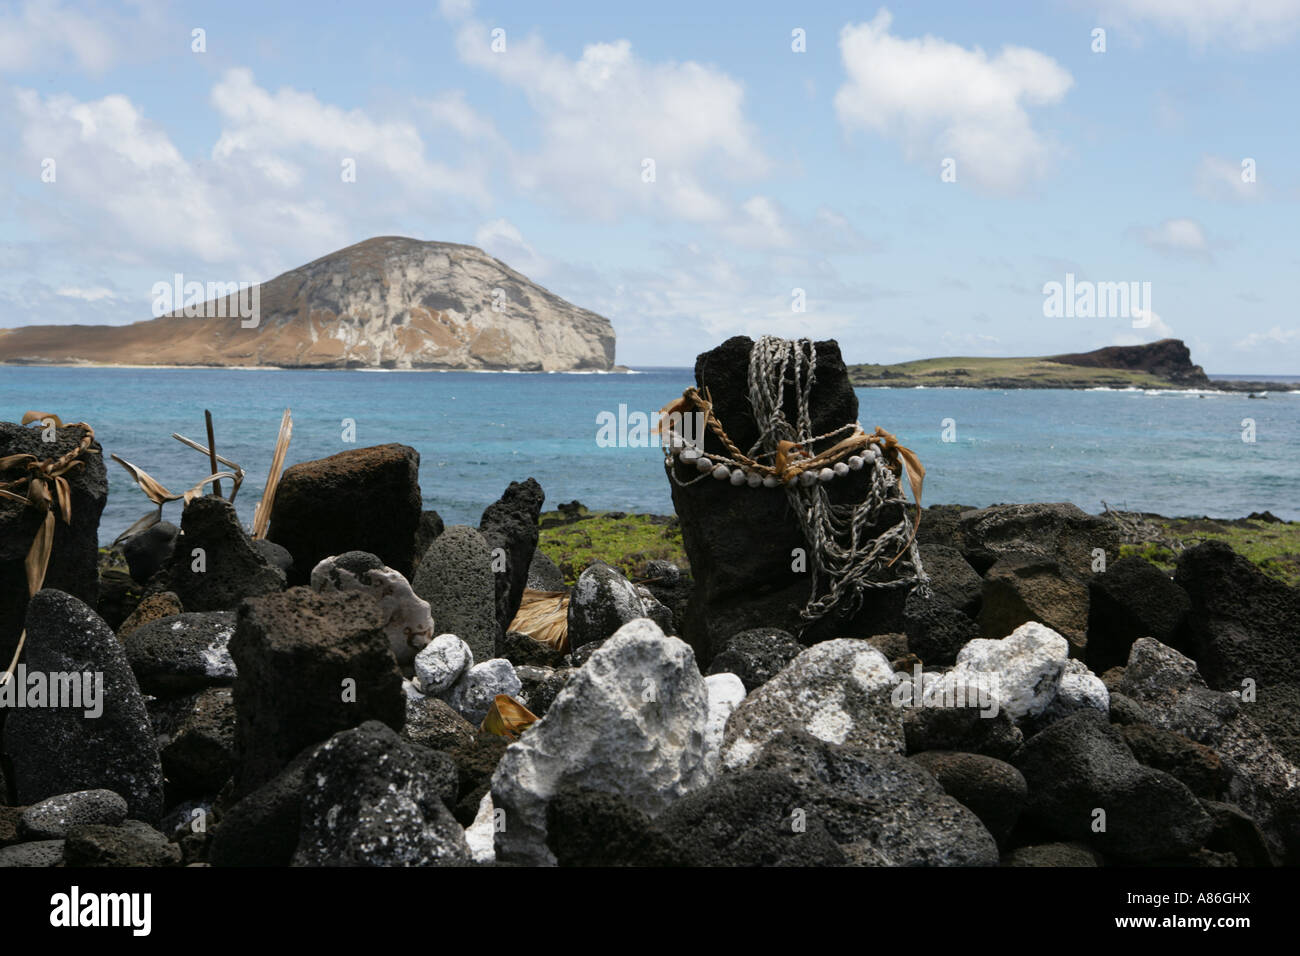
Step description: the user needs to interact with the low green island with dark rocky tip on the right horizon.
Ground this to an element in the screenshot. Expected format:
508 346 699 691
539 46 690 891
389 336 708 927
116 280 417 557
849 338 1295 392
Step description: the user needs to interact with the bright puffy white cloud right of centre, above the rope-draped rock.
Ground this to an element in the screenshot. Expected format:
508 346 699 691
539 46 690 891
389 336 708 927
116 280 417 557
835 8 1074 193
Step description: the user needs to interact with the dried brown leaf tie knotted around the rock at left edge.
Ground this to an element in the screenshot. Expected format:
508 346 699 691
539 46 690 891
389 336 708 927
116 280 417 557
0 411 99 685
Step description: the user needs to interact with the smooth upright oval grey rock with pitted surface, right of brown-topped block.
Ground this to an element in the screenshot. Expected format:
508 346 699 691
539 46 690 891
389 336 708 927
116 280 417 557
411 524 497 661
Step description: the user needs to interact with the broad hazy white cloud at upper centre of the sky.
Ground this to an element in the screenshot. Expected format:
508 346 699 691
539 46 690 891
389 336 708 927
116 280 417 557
456 12 768 224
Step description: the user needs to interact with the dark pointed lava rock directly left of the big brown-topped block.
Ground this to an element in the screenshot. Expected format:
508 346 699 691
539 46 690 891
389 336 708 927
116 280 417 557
160 496 285 611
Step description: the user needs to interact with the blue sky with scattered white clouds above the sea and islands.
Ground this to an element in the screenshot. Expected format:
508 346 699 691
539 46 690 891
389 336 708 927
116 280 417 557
0 0 1300 376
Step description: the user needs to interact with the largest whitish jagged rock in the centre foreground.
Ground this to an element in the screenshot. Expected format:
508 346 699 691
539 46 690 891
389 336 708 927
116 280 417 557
491 619 709 864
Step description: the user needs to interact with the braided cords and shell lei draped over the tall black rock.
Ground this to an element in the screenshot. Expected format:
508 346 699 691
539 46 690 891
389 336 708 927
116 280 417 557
659 336 930 623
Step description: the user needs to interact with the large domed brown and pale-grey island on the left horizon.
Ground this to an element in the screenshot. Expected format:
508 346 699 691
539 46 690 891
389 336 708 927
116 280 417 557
0 237 614 372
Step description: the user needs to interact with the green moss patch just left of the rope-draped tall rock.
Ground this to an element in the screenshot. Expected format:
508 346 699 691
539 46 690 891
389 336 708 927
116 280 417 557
538 506 688 585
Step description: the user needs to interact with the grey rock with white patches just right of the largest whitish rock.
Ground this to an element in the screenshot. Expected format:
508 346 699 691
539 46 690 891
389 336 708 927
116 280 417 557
723 639 905 770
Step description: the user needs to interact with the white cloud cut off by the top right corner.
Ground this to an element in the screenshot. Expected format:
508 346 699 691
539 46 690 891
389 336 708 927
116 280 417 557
1096 0 1300 49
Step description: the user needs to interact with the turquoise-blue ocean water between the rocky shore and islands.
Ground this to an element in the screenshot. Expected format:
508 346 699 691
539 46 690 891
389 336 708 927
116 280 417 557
0 367 1300 542
